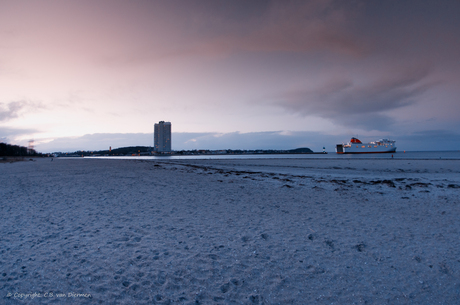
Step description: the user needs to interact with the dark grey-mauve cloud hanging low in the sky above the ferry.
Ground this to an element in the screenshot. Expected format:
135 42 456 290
273 67 435 130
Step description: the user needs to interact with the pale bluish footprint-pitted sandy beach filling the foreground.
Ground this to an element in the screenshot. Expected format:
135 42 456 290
0 158 460 304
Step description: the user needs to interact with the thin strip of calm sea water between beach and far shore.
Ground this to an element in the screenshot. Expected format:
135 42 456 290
85 150 460 160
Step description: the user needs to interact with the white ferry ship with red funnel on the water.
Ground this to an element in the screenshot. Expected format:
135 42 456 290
335 138 396 154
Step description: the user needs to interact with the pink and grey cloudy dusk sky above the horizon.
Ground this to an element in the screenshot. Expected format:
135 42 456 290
0 0 460 152
